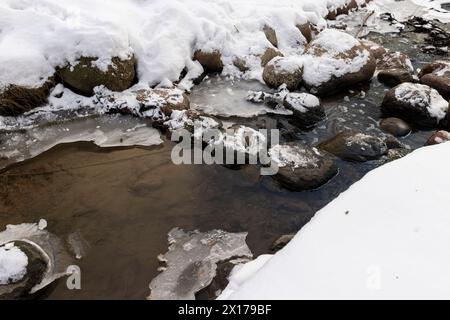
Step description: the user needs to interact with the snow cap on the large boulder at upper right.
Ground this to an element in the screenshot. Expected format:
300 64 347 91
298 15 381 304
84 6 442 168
302 29 370 86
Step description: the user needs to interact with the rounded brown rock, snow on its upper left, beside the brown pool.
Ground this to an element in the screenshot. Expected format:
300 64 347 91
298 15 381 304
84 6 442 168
269 142 338 191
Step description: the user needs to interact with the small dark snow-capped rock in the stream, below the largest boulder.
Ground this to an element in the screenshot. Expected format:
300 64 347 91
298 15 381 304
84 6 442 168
283 92 325 129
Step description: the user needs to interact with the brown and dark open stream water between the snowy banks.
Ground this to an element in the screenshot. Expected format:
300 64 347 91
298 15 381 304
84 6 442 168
0 28 442 299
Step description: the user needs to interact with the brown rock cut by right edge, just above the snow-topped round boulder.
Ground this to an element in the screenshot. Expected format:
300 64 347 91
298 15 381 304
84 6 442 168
419 60 450 99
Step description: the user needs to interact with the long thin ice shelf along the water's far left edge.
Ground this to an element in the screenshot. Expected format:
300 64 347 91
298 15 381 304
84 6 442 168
0 115 163 168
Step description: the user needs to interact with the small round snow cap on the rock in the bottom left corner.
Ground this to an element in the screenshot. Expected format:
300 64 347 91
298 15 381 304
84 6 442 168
0 243 28 285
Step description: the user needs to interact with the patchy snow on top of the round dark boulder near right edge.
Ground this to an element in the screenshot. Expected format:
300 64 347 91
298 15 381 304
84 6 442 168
395 82 448 120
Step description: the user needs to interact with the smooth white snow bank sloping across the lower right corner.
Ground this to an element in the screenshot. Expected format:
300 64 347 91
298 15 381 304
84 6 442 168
221 143 450 299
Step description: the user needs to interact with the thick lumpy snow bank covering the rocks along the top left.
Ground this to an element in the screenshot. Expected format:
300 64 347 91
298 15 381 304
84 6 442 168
0 0 358 86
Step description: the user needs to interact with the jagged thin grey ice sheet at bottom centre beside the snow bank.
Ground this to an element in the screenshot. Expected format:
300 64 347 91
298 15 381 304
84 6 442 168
148 228 252 300
